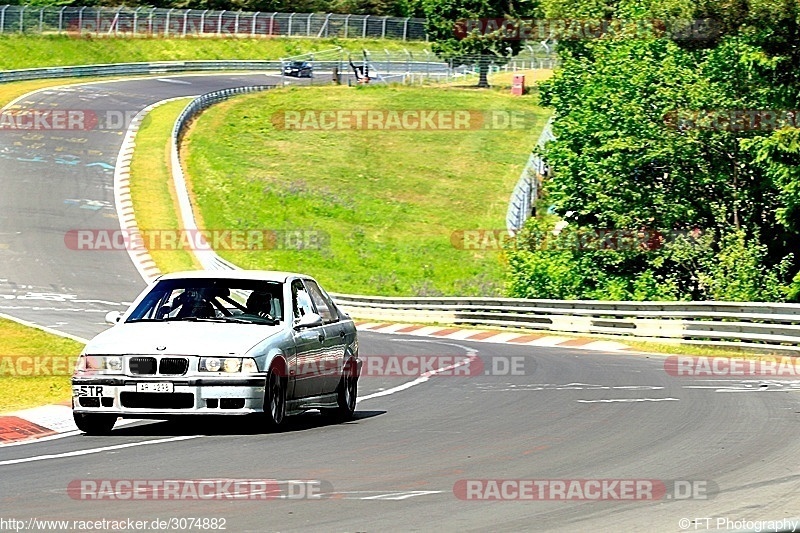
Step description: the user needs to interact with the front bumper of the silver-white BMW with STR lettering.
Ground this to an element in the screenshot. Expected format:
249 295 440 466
72 376 266 418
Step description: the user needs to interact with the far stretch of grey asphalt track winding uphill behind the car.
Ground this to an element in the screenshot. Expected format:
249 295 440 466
0 74 288 337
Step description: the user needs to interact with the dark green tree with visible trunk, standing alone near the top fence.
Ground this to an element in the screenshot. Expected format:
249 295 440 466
422 0 539 87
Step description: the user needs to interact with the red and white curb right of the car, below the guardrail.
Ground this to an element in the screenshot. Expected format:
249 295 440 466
356 321 630 352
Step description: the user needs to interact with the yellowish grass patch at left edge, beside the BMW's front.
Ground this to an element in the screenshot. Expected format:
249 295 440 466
0 319 83 412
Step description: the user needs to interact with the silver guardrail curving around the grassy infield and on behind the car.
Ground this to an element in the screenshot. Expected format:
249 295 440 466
164 86 800 352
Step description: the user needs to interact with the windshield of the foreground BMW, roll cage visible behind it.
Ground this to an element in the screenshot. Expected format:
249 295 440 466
126 279 283 324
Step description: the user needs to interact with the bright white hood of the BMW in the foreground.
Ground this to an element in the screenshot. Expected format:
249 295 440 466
84 322 282 356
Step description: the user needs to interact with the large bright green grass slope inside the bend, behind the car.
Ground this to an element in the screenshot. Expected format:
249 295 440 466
184 85 547 296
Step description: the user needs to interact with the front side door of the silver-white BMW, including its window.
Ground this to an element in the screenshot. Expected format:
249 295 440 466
290 279 325 398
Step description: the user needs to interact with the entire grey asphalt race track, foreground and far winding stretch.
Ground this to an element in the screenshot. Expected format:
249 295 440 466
0 75 800 532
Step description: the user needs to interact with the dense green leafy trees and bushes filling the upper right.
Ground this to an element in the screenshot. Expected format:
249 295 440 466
508 0 800 300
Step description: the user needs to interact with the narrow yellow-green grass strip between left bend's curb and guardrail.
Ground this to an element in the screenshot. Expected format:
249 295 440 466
131 98 200 272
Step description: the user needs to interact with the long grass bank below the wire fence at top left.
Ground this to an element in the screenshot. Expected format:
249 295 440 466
0 35 430 70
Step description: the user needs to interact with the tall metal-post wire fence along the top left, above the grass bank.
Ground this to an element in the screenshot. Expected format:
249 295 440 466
0 5 427 41
